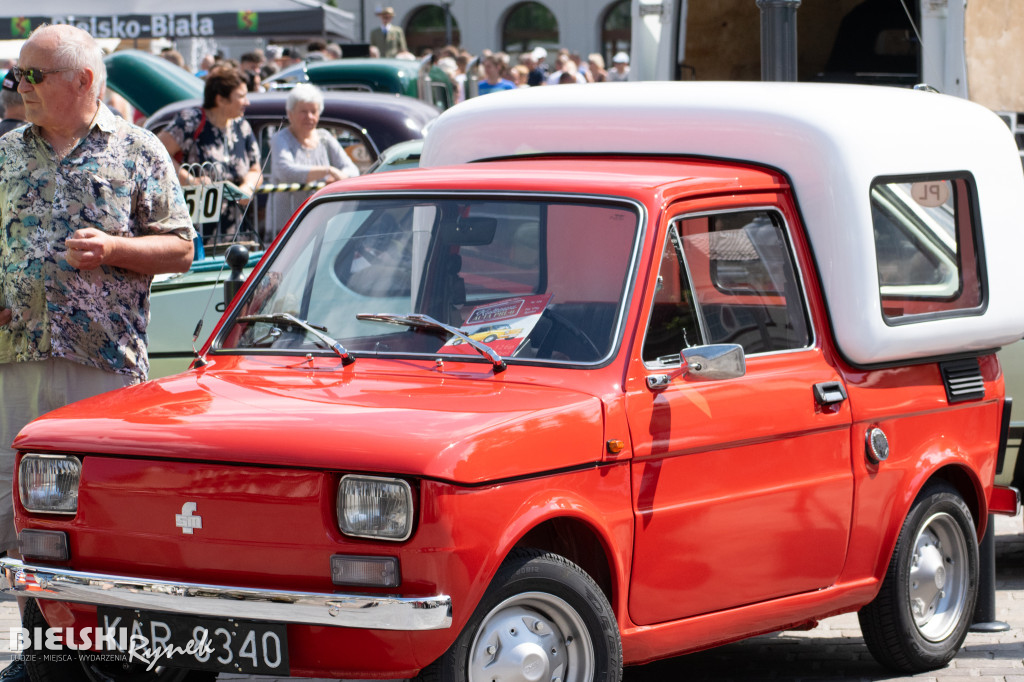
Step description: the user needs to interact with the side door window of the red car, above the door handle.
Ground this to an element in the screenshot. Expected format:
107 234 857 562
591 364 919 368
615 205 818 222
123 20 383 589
643 210 811 364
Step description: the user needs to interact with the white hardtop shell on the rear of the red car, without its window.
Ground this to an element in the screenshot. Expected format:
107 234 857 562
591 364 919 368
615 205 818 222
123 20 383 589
421 82 1024 366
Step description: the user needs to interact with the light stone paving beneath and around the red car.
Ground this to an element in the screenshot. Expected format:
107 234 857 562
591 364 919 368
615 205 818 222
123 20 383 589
0 515 1024 682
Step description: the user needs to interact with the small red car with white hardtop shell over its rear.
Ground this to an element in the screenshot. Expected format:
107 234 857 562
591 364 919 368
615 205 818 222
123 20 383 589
0 83 1024 682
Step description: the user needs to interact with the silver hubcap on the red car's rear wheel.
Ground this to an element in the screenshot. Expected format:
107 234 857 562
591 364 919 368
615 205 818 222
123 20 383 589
907 512 969 642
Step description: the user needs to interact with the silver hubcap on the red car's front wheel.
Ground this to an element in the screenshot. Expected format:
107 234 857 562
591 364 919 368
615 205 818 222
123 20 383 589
469 592 594 682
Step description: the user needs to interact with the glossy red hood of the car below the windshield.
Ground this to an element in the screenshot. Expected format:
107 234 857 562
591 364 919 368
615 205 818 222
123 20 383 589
14 360 604 483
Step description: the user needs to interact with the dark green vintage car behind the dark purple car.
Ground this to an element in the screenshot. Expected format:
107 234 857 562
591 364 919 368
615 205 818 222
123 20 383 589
265 57 455 112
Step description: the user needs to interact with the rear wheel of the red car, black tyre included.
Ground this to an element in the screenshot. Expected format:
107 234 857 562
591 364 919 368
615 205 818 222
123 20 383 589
858 483 978 674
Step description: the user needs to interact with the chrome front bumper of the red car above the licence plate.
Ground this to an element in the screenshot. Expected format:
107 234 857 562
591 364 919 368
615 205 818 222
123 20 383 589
0 557 452 631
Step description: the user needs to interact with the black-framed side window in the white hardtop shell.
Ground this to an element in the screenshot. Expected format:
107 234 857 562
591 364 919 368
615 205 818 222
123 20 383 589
871 174 985 325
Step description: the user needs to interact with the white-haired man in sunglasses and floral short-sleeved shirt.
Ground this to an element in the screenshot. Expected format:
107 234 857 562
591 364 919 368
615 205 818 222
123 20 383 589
0 25 195 680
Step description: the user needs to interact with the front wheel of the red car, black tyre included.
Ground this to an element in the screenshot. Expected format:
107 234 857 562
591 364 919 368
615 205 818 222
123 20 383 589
416 550 623 682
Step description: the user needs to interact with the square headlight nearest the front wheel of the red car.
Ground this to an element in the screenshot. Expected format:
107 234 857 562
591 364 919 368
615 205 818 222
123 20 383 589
338 475 413 541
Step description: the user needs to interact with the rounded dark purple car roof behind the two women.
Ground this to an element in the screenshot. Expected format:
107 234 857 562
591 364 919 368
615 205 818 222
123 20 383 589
145 91 437 153
